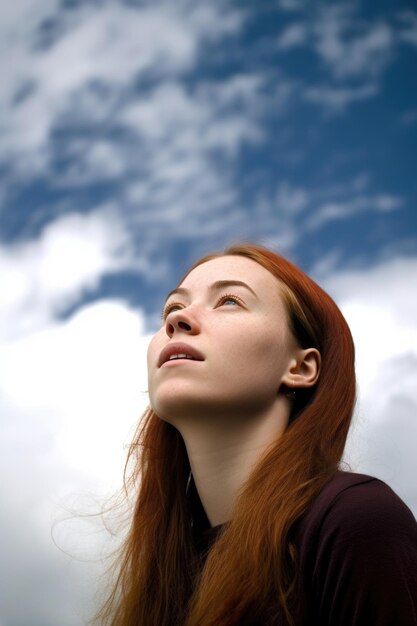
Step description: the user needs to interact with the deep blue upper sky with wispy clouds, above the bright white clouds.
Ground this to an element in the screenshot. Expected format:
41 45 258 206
0 1 417 322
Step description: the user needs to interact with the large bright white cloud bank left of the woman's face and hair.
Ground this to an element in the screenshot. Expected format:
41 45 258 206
0 202 149 626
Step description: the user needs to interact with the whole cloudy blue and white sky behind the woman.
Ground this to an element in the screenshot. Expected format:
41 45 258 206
0 0 417 626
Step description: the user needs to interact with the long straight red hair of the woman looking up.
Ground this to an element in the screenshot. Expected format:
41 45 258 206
94 244 355 626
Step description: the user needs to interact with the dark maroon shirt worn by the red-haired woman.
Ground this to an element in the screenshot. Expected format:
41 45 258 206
189 472 417 626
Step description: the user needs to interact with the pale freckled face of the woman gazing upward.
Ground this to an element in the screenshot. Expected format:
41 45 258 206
148 256 299 421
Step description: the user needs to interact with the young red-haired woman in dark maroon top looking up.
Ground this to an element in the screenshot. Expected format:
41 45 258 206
100 245 417 626
